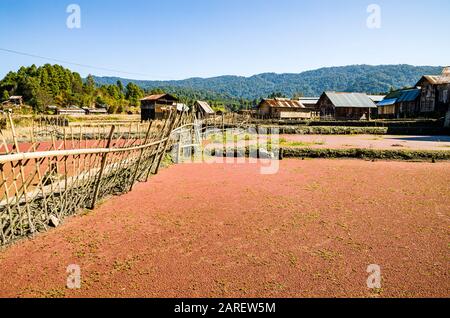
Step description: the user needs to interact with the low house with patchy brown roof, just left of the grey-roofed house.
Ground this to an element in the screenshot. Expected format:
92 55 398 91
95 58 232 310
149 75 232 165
258 98 314 119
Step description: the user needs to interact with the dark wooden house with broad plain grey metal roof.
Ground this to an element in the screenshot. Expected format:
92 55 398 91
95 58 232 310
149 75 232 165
316 92 377 120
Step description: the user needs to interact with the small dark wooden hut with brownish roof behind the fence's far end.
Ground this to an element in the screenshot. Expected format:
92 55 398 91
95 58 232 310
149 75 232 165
141 94 178 121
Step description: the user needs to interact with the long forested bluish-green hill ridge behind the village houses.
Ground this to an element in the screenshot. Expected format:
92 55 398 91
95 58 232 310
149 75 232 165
95 65 442 99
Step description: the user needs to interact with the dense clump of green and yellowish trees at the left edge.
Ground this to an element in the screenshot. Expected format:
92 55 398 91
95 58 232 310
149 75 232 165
0 64 151 113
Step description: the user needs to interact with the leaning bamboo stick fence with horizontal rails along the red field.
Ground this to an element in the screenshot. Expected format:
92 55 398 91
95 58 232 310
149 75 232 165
0 113 190 245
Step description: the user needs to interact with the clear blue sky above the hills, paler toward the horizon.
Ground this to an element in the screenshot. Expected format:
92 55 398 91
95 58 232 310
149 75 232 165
0 0 450 80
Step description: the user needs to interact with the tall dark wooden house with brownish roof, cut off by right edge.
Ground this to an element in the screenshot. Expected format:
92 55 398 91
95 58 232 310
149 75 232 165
416 67 450 117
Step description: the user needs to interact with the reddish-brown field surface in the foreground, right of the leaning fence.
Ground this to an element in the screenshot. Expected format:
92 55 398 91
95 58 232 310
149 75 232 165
0 160 450 297
